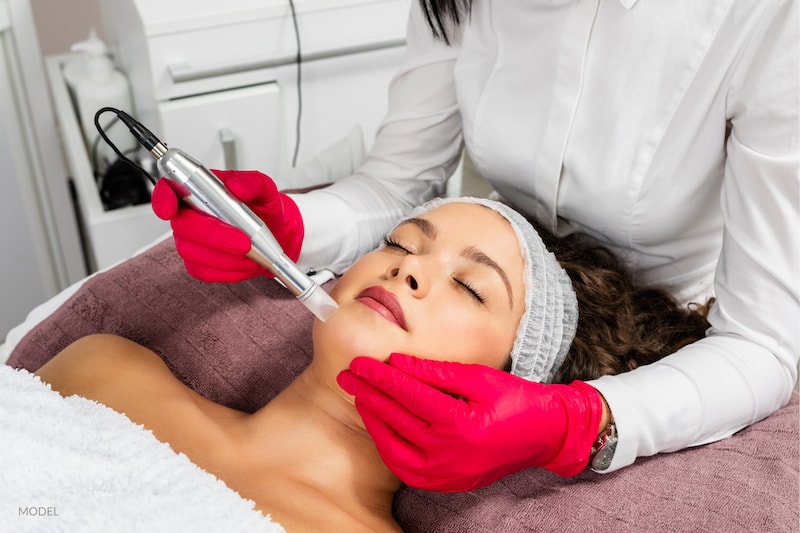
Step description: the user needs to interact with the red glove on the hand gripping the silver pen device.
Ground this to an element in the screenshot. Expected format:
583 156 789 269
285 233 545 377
151 170 304 282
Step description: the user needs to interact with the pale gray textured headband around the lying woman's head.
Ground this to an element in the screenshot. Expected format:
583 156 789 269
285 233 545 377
408 197 578 383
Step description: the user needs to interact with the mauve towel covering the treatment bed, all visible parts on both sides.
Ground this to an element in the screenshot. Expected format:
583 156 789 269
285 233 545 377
8 240 800 533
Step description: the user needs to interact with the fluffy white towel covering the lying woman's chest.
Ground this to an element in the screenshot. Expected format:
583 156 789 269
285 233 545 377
0 365 284 533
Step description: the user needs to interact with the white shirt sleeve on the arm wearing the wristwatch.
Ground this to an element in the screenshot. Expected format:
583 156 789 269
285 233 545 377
592 2 800 472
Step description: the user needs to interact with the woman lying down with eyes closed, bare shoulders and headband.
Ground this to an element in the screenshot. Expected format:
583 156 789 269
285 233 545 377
37 198 706 532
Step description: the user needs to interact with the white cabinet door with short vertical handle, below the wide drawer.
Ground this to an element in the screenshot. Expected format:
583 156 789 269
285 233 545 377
159 83 286 182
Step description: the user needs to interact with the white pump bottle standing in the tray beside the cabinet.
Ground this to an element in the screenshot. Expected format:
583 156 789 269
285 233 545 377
71 30 138 176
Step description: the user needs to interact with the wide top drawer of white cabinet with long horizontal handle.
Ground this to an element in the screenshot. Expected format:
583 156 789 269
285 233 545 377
101 0 409 101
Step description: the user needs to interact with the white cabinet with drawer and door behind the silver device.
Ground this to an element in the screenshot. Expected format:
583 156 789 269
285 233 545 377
101 0 409 188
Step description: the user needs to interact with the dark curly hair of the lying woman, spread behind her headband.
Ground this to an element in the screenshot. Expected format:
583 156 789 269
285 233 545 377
536 226 713 383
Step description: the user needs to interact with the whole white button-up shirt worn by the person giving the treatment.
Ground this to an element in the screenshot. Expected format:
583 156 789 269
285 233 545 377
296 0 800 471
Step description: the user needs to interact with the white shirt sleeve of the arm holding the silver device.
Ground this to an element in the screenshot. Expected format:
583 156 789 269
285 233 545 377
292 2 462 272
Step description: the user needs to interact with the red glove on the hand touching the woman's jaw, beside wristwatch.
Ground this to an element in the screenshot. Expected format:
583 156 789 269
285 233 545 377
338 354 603 492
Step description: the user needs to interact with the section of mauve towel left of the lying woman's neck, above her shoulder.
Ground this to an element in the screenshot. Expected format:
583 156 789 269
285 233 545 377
7 239 313 412
